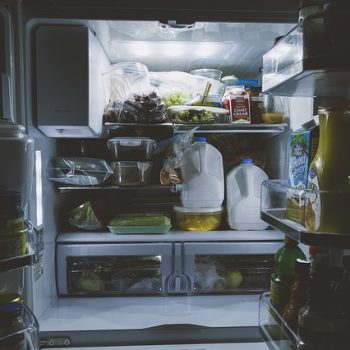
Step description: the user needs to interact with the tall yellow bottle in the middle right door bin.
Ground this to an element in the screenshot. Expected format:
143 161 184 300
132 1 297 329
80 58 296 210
305 100 350 234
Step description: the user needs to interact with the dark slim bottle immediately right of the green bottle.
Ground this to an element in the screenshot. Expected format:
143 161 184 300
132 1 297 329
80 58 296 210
282 259 310 331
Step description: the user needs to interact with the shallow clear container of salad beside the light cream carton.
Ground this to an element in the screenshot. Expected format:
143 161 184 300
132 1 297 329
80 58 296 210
167 106 230 124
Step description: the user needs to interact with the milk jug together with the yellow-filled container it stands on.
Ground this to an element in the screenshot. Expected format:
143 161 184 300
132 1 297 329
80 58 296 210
174 137 224 231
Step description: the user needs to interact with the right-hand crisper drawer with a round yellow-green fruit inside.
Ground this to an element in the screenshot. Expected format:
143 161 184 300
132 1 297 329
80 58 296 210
184 242 282 294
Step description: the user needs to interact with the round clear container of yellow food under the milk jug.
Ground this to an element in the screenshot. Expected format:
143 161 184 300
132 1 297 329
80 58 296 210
174 206 223 231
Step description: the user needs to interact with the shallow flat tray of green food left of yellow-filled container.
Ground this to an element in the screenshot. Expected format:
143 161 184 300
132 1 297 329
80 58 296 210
108 214 171 234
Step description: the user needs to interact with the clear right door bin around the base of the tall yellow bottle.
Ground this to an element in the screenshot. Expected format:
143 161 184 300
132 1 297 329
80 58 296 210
261 180 350 249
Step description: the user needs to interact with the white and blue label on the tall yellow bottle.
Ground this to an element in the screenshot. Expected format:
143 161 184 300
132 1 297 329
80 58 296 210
305 168 321 231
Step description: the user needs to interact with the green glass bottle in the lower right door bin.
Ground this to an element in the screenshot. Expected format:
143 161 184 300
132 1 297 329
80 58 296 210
270 236 306 313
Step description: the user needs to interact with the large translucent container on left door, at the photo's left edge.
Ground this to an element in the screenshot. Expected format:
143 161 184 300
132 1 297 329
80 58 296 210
0 119 34 209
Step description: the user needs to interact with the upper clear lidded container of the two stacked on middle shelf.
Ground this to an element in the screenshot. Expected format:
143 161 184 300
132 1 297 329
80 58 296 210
107 137 156 160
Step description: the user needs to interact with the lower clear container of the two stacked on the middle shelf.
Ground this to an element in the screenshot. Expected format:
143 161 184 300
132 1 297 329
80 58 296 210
111 161 152 186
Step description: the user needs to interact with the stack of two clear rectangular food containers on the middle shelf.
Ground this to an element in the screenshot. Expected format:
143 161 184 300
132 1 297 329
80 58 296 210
107 137 156 186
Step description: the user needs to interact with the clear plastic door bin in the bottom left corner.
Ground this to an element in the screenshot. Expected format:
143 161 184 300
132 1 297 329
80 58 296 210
0 304 39 350
